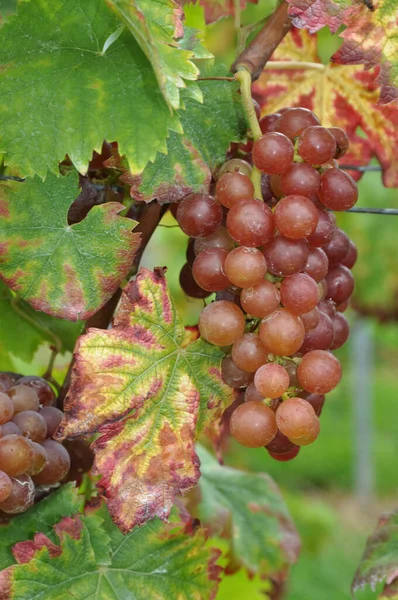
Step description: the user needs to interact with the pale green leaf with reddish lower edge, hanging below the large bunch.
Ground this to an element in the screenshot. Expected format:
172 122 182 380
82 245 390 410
197 447 300 581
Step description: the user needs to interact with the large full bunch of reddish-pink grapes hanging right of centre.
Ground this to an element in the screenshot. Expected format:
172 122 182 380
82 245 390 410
176 108 358 461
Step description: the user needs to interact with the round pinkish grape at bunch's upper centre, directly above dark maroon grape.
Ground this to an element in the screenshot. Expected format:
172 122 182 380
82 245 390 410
275 196 319 240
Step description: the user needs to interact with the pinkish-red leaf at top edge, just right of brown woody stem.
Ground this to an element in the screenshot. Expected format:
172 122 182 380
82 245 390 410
287 0 360 33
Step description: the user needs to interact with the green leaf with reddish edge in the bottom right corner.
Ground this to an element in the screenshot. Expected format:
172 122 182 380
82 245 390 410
352 512 398 598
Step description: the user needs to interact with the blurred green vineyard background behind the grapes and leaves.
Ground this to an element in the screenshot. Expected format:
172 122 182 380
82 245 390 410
7 0 398 600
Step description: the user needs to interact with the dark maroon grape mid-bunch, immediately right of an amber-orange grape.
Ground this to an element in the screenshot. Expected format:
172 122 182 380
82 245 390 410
263 235 309 277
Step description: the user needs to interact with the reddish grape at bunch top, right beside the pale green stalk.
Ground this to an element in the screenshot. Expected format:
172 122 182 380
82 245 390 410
252 132 294 175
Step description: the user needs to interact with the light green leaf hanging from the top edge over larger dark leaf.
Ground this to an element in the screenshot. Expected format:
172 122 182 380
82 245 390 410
106 0 212 109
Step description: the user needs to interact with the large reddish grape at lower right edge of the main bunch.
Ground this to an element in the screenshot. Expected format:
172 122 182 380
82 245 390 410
297 350 341 394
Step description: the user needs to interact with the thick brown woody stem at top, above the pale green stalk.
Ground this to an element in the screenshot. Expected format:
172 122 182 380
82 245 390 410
231 1 292 81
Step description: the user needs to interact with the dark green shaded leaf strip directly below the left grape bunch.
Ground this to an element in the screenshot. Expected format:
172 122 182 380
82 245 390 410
0 483 82 572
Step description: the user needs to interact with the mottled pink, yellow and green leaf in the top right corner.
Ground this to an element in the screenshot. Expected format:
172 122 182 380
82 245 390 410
331 0 398 104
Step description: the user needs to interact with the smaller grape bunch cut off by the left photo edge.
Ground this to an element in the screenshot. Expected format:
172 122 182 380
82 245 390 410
0 373 70 515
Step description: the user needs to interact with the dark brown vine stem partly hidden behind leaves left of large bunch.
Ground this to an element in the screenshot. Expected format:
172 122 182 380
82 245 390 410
57 201 167 410
